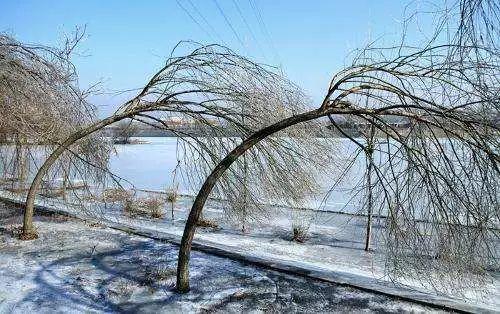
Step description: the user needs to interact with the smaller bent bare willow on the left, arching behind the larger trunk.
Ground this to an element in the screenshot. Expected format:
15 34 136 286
23 43 328 239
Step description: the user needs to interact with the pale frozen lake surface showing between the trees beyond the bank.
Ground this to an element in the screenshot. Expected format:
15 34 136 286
0 137 380 213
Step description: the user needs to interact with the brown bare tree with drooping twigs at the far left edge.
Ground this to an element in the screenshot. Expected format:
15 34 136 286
0 29 110 237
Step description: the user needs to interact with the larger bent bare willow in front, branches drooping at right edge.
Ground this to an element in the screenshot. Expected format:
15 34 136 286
177 0 500 292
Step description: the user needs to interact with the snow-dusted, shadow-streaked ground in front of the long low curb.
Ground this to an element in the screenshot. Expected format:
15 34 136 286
0 204 440 313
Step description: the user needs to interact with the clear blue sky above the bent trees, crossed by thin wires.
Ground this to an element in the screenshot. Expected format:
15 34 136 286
0 0 414 115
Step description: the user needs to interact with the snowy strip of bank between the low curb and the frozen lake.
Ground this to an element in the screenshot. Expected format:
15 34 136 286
0 188 500 312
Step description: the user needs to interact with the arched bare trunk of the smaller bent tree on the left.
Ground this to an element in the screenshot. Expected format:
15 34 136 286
19 110 140 240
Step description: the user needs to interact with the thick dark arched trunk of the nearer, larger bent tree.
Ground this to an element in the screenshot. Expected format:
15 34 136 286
176 107 333 293
